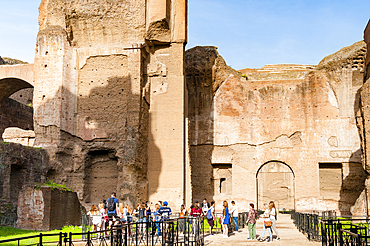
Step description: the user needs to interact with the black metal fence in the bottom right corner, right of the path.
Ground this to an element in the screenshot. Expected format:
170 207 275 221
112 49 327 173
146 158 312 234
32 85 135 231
291 211 370 246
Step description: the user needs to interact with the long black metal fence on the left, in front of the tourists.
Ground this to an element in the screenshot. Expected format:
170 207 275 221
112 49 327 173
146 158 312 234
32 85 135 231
0 212 248 246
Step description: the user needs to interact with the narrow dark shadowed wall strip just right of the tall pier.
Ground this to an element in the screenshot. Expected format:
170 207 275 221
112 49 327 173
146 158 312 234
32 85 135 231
185 47 220 203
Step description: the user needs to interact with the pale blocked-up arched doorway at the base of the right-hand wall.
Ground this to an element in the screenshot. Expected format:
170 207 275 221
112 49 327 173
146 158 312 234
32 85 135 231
257 161 295 210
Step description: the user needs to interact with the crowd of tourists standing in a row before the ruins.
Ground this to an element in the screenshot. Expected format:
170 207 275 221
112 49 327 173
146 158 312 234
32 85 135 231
87 192 280 242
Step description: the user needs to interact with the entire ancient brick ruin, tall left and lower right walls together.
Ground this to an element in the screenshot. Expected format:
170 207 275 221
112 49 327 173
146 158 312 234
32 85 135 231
0 0 369 214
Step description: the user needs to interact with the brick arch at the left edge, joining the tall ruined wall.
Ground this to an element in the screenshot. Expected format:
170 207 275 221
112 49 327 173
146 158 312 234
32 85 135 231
0 64 34 104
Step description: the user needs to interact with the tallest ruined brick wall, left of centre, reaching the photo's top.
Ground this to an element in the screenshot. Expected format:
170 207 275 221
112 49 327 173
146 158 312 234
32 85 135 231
34 0 187 209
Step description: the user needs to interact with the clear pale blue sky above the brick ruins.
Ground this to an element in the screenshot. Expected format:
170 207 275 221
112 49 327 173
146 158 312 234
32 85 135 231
0 0 370 69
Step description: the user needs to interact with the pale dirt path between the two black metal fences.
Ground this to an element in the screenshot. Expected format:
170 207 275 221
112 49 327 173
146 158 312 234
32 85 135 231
205 214 321 246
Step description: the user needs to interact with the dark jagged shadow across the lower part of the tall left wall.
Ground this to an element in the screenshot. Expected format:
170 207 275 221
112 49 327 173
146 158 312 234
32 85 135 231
35 69 160 208
